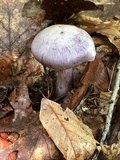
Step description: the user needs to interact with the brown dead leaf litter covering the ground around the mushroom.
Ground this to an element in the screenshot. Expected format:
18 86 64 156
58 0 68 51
0 0 120 160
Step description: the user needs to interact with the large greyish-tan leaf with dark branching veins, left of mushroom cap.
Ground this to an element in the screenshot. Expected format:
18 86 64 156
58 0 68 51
0 0 44 51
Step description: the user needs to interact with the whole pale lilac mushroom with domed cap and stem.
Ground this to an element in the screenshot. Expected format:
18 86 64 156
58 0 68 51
31 24 96 96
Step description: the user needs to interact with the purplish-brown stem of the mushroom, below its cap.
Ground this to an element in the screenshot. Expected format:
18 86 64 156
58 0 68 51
56 68 73 97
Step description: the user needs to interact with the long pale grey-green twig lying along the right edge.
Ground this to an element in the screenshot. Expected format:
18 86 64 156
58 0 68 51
100 59 120 144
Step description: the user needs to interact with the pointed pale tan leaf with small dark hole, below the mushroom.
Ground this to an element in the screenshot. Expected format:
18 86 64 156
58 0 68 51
40 98 97 160
